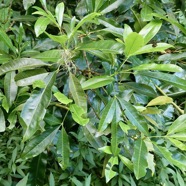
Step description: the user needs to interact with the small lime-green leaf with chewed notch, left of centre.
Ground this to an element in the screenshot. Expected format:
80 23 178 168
70 104 89 126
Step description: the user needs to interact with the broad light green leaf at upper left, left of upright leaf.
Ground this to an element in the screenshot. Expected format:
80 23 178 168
34 17 50 37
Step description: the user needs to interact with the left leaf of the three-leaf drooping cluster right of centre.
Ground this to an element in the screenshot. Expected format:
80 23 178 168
98 99 116 131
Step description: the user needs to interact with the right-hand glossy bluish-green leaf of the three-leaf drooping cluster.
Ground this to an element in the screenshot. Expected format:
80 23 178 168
118 98 149 136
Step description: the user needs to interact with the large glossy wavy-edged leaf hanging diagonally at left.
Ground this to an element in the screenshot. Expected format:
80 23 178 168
21 72 56 141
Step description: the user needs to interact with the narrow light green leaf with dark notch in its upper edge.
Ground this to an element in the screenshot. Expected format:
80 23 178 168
132 43 174 55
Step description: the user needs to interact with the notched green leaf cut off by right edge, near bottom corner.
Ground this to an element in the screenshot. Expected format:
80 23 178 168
154 143 186 171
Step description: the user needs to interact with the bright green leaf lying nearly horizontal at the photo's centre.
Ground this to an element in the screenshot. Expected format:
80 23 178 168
81 75 114 90
